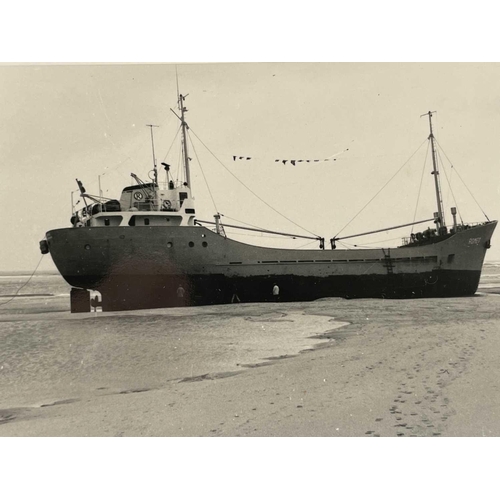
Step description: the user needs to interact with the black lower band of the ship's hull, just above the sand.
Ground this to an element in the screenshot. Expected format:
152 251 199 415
71 271 481 311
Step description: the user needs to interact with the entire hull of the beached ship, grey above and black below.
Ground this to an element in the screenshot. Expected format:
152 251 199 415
47 222 496 311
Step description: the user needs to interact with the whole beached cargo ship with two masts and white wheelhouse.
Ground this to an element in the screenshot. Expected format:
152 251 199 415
40 94 497 312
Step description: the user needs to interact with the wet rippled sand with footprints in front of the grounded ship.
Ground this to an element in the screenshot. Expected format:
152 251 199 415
0 294 500 436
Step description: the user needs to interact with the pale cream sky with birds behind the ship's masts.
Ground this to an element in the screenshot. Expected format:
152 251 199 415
0 63 500 271
